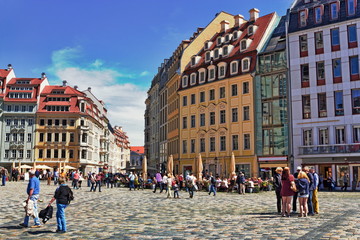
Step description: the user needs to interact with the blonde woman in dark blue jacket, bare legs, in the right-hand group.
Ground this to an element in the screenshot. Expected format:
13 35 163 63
296 171 310 217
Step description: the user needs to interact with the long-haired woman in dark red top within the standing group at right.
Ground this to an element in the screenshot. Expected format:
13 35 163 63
281 167 295 217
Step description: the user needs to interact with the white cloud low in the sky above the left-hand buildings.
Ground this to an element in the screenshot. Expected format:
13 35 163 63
48 47 149 146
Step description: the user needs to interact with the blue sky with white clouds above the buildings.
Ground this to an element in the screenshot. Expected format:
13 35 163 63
0 0 291 146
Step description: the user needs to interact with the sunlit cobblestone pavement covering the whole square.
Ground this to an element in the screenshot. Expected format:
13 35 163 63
0 182 360 239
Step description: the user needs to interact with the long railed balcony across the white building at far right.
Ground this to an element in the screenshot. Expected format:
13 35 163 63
299 143 360 155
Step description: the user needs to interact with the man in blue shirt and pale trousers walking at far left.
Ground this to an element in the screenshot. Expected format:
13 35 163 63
20 169 41 228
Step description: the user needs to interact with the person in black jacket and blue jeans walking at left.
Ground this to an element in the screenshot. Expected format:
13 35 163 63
48 178 73 233
